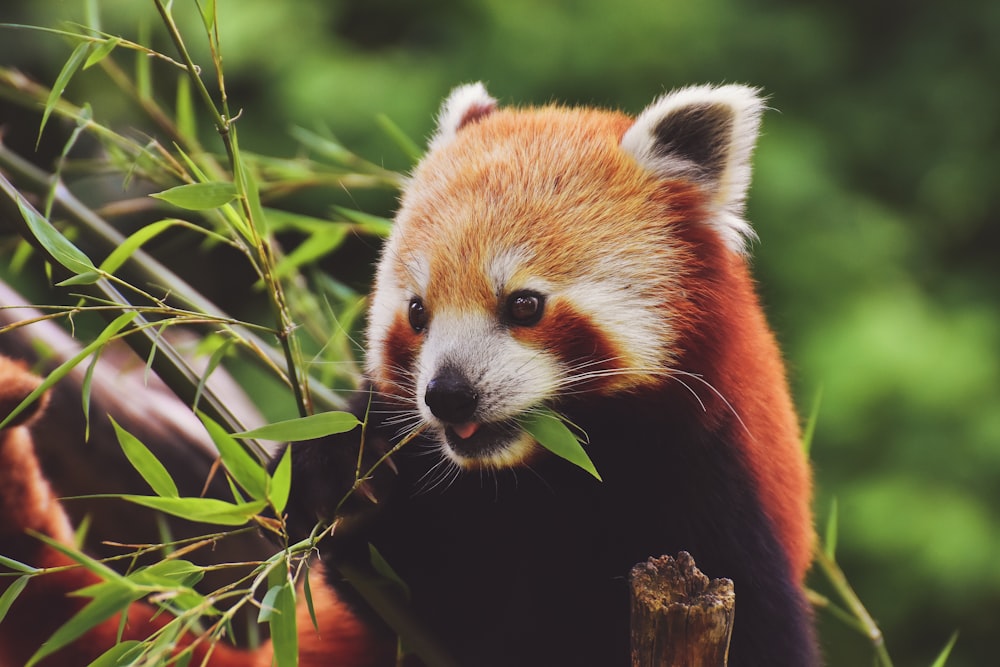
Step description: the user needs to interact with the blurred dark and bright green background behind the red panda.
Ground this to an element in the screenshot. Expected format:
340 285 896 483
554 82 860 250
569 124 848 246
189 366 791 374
0 0 1000 667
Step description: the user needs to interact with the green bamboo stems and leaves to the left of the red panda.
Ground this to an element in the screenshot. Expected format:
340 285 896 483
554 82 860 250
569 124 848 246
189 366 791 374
0 0 414 665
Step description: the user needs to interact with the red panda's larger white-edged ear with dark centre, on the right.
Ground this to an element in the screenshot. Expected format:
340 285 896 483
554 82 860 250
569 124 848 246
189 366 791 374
621 85 764 252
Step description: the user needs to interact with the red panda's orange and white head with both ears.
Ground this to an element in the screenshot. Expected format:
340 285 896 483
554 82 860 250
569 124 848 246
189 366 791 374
368 84 762 467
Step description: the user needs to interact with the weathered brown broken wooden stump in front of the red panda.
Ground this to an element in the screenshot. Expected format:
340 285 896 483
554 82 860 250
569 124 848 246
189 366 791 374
629 551 736 667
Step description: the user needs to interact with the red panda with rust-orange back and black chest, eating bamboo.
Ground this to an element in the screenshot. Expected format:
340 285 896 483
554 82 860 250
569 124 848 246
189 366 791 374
0 84 819 667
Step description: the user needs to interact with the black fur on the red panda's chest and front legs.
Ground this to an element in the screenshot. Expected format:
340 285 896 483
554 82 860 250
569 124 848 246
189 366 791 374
292 398 817 667
